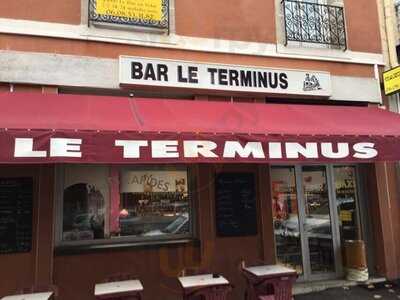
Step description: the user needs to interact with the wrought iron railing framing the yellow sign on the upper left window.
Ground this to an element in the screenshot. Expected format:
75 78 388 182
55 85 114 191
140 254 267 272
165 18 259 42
88 0 169 30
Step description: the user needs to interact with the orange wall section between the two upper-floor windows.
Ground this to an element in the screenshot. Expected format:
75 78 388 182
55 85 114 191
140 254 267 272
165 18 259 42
175 0 276 43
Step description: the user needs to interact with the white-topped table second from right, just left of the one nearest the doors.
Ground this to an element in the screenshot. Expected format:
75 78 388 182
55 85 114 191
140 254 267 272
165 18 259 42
178 274 232 300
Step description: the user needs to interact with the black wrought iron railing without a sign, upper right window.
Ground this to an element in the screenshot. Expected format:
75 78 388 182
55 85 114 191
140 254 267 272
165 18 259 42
282 0 347 49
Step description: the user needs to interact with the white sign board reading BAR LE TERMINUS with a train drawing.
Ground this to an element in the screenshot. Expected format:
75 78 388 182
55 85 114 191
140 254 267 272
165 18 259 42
119 56 332 97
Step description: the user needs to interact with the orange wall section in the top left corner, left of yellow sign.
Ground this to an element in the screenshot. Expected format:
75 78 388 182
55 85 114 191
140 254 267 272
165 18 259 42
0 0 81 24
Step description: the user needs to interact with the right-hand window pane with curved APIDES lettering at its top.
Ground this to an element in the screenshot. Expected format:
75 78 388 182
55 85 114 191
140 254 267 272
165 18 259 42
118 171 189 236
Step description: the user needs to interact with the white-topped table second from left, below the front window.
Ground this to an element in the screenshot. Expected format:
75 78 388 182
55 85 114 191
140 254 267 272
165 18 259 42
94 280 143 300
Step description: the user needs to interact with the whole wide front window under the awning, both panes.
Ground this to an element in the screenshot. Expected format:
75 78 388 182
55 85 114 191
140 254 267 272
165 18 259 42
58 165 192 244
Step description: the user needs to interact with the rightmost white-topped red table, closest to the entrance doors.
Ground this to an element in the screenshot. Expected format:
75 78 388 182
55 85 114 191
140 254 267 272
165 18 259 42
242 265 297 300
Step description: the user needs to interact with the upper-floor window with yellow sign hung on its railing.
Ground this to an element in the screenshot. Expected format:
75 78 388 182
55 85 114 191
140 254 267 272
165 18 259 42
89 0 170 30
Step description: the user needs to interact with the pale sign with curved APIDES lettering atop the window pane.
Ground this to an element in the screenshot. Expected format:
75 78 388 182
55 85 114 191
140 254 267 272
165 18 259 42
121 170 188 193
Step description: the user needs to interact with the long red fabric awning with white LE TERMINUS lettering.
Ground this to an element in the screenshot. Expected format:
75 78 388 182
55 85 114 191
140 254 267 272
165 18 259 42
0 93 400 163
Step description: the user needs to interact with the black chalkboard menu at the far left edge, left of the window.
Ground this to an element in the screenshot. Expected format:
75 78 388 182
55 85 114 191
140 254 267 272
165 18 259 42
0 178 33 254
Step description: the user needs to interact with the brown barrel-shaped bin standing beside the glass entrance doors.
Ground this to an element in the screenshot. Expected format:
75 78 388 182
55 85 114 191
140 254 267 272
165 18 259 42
344 240 369 282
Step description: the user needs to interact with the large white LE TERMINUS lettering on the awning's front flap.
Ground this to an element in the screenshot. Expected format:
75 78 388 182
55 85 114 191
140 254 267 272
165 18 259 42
14 138 378 161
